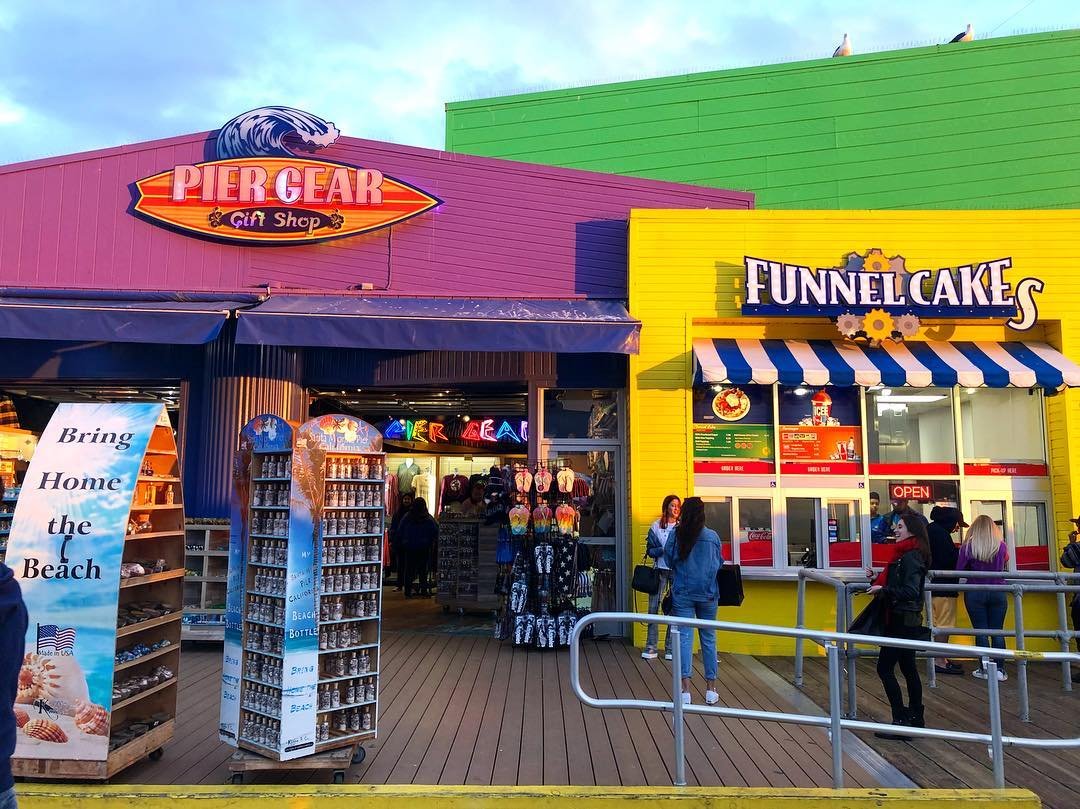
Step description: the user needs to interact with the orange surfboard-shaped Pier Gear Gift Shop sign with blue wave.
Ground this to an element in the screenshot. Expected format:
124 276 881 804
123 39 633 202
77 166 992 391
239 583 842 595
134 107 440 244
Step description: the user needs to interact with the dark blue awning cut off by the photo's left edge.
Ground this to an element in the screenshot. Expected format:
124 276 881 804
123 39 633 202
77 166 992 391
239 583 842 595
0 289 261 345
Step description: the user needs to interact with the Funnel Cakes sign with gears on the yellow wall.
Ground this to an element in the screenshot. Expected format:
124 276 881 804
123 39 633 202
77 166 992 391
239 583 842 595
742 250 1044 337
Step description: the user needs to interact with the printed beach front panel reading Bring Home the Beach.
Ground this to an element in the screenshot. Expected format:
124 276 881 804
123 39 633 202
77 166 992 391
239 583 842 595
8 404 162 761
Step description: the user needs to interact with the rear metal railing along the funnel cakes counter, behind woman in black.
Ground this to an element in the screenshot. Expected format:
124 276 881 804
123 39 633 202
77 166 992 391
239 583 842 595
795 568 1080 722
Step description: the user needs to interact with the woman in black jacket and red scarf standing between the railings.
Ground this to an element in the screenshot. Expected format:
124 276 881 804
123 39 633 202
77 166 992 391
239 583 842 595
869 511 930 739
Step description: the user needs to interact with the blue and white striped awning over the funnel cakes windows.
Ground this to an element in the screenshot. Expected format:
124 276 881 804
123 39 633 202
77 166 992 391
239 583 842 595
693 339 1080 391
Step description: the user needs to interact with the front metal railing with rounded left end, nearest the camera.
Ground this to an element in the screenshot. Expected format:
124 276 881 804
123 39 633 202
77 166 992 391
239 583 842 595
570 612 1080 788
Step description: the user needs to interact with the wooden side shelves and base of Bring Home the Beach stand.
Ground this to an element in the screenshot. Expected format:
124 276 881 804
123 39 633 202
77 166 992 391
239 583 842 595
11 409 184 780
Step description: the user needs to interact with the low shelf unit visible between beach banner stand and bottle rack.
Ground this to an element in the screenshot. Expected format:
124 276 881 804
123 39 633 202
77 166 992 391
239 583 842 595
180 521 229 641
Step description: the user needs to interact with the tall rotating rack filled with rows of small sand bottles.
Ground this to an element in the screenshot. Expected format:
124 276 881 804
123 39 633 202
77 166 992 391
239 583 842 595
219 415 386 760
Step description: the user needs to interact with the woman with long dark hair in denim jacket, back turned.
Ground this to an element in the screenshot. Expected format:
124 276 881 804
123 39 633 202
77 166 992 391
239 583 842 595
664 497 724 705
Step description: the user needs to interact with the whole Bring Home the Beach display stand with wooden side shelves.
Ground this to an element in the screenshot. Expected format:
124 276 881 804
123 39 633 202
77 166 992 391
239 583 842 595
9 404 184 779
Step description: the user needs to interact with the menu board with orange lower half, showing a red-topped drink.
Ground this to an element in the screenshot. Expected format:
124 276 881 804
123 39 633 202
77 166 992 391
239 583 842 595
780 386 863 474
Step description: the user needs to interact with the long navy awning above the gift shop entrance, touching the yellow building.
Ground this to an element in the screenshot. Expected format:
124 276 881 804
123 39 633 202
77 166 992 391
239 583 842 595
237 295 640 354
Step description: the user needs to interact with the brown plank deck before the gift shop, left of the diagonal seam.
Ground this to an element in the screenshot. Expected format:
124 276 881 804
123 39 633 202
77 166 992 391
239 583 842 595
113 591 880 787
